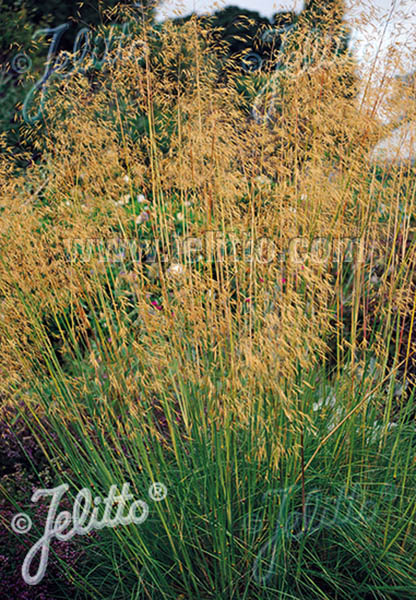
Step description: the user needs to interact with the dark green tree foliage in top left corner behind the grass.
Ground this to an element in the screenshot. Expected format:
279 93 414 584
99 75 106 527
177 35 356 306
0 0 157 162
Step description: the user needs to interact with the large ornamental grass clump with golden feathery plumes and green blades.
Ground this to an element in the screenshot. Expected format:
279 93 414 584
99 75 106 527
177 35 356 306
0 2 416 600
